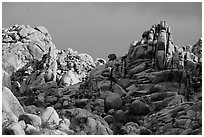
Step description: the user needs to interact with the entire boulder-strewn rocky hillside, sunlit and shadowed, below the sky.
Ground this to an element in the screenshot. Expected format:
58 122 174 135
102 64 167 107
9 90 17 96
2 21 202 135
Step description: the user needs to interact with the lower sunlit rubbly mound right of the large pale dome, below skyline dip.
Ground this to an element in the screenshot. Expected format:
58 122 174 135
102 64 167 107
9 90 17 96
57 49 95 85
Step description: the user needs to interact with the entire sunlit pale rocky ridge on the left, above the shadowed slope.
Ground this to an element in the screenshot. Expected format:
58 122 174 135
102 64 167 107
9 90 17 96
2 25 95 91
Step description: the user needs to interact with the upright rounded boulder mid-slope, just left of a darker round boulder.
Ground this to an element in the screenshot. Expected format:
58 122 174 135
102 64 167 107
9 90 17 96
105 93 122 110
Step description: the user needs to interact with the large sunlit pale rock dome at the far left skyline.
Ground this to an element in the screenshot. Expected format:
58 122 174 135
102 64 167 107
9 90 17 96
2 25 56 74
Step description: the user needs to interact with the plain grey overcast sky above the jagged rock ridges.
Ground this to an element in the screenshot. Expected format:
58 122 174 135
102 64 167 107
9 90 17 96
2 2 202 59
